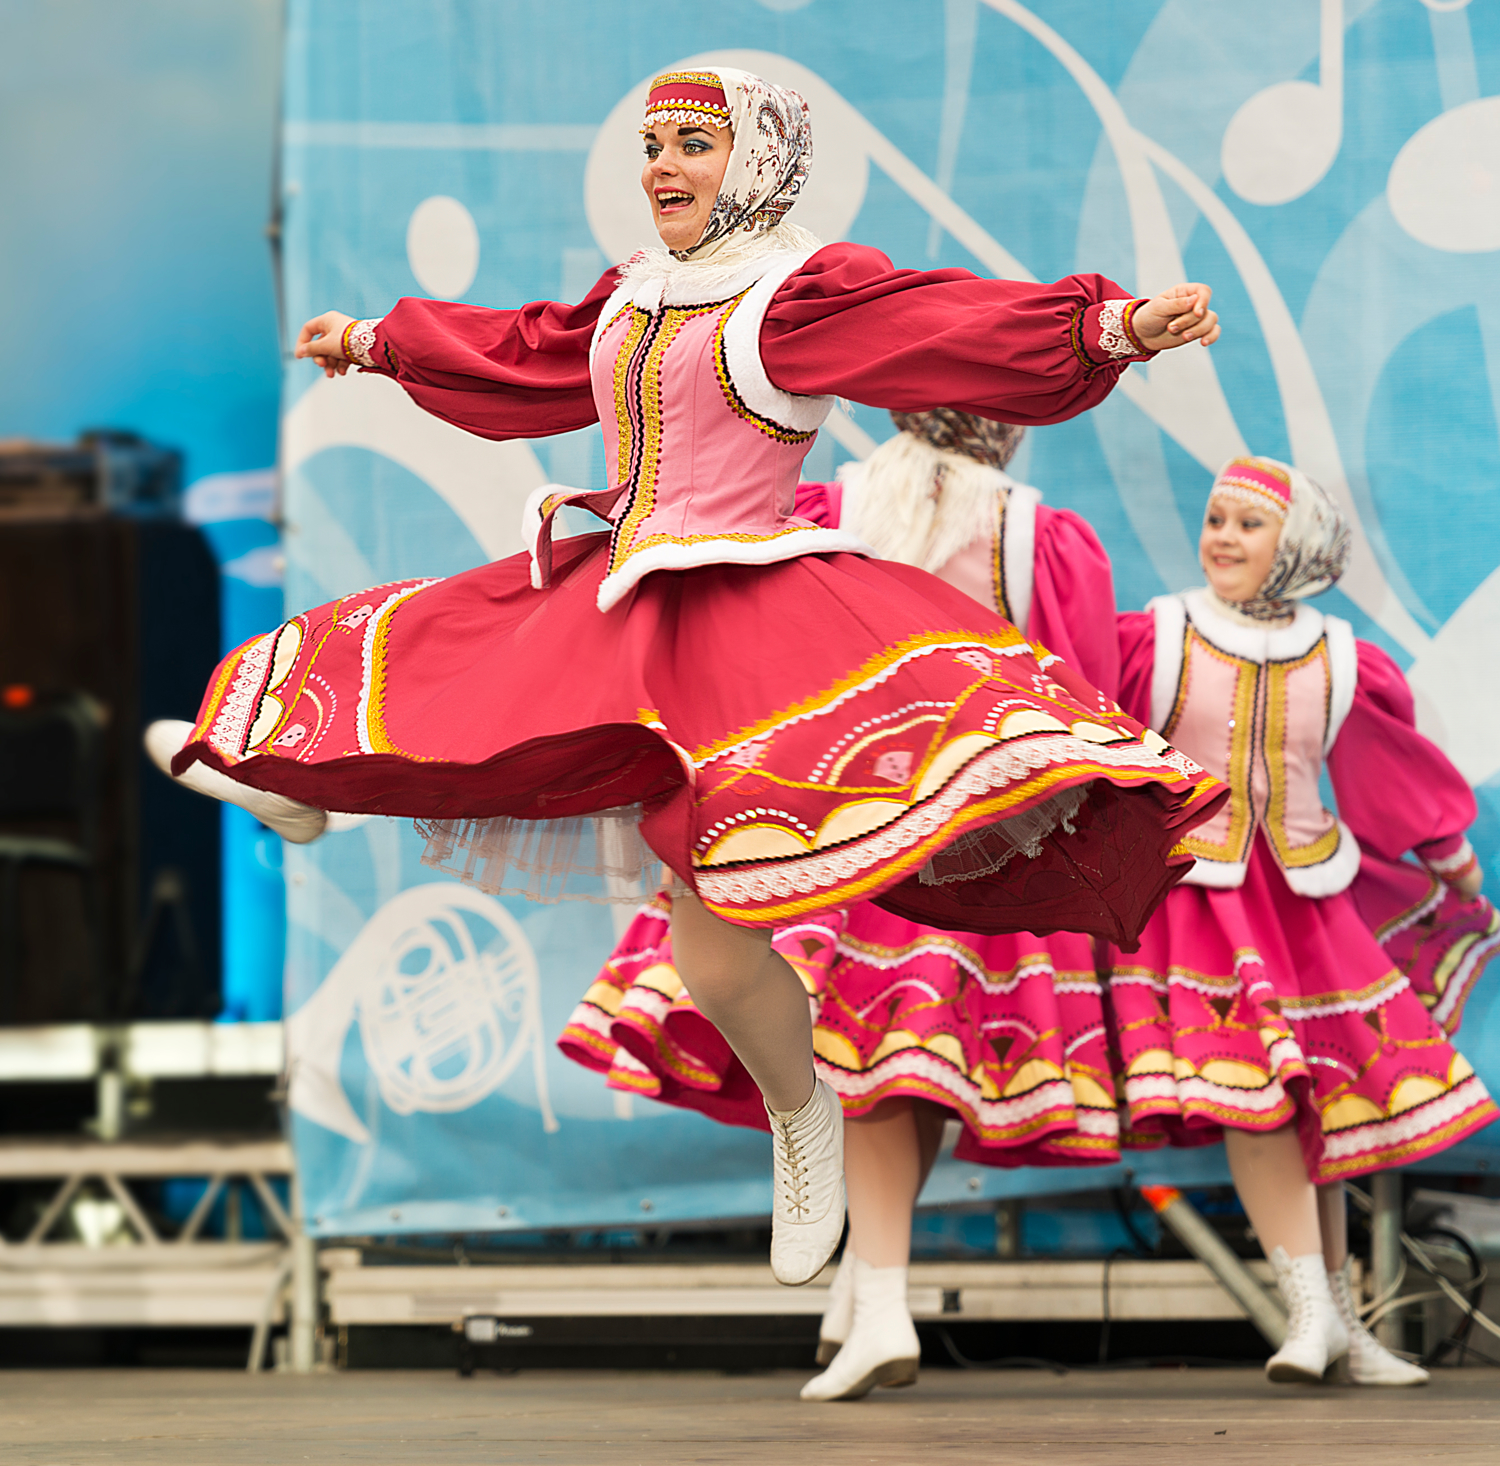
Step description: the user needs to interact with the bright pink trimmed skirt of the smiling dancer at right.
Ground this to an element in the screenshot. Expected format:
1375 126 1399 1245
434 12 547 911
1107 837 1497 1182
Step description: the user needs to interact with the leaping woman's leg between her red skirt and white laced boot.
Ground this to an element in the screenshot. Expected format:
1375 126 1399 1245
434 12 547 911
672 893 813 1112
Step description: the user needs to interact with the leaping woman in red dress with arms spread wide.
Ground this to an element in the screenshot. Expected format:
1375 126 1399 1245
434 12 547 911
149 69 1224 1283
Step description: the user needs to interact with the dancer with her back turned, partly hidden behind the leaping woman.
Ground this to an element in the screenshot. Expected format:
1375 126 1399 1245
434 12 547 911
560 408 1119 1400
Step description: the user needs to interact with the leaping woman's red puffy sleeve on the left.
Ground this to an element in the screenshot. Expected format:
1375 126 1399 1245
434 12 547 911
369 269 618 438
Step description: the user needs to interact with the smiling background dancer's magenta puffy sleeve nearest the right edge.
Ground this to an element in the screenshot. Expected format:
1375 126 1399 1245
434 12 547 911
1328 641 1478 881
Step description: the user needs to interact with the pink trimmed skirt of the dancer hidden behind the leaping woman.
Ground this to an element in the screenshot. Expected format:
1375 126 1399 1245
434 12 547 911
558 894 1119 1166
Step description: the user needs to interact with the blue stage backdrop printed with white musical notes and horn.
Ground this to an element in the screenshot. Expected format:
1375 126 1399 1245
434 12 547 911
282 0 1500 1233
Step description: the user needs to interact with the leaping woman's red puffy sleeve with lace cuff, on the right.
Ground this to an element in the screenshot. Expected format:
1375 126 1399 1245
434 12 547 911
761 245 1154 425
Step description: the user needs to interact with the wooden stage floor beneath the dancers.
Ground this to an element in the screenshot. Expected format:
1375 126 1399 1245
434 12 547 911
0 1368 1500 1466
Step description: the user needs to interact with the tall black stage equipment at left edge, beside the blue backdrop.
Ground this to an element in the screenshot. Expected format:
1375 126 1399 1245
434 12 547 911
0 450 221 1023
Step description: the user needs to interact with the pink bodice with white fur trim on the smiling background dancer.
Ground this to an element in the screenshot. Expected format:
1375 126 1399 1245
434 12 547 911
1148 591 1359 896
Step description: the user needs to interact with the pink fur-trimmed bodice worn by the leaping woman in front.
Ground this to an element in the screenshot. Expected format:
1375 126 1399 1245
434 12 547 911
528 254 866 611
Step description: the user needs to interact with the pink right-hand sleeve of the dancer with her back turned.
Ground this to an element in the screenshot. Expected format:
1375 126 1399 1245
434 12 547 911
1025 504 1121 701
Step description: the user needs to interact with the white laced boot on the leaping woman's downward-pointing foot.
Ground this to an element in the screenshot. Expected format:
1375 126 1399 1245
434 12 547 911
765 1079 845 1287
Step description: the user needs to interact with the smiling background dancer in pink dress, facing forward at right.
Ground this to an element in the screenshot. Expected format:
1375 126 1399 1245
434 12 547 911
1109 458 1497 1385
